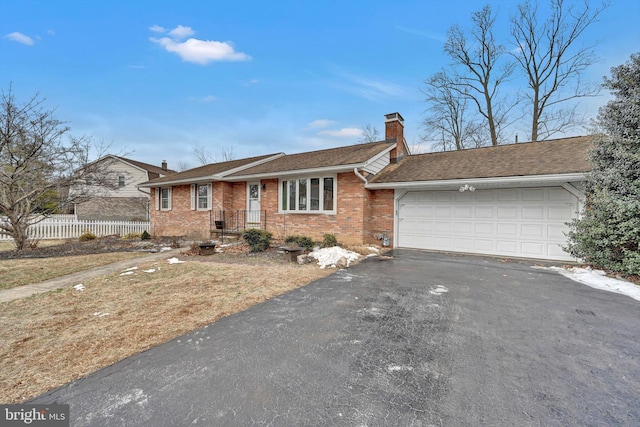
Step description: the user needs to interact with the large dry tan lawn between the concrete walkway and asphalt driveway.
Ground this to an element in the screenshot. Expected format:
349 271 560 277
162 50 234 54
0 255 332 403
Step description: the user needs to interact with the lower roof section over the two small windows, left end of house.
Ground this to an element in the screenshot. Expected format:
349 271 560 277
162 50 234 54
140 153 284 187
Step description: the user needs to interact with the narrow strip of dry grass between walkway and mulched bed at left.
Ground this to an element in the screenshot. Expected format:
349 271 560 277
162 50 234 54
0 252 146 290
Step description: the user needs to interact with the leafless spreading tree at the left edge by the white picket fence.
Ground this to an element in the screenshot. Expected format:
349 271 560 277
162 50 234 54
0 86 117 250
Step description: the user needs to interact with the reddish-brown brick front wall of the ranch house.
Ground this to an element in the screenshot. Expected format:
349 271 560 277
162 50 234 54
151 172 394 244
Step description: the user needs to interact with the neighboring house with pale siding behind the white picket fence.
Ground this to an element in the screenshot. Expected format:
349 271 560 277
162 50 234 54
74 155 176 221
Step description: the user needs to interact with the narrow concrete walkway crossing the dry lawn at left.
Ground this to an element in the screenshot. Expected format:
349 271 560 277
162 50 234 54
0 249 181 303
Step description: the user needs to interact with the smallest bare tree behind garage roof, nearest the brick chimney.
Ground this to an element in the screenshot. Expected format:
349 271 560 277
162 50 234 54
422 71 482 151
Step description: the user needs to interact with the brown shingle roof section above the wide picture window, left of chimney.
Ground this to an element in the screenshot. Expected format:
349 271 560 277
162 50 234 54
229 139 395 177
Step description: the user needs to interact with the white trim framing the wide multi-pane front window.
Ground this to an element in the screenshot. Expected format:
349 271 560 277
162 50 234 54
278 174 338 215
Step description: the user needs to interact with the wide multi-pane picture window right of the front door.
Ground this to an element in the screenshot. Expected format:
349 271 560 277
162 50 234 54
280 177 336 213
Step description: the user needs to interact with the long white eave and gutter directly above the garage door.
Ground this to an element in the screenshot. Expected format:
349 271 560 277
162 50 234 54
365 172 587 190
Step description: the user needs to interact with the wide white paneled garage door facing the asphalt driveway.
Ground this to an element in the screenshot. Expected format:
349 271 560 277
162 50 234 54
397 187 578 260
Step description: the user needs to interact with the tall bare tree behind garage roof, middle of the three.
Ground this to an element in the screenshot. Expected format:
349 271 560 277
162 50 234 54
444 5 516 145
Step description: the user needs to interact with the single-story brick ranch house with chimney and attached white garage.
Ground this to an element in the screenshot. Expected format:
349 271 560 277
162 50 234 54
140 113 590 260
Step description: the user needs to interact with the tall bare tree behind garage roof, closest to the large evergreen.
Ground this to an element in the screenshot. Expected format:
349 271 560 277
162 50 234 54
511 0 607 141
